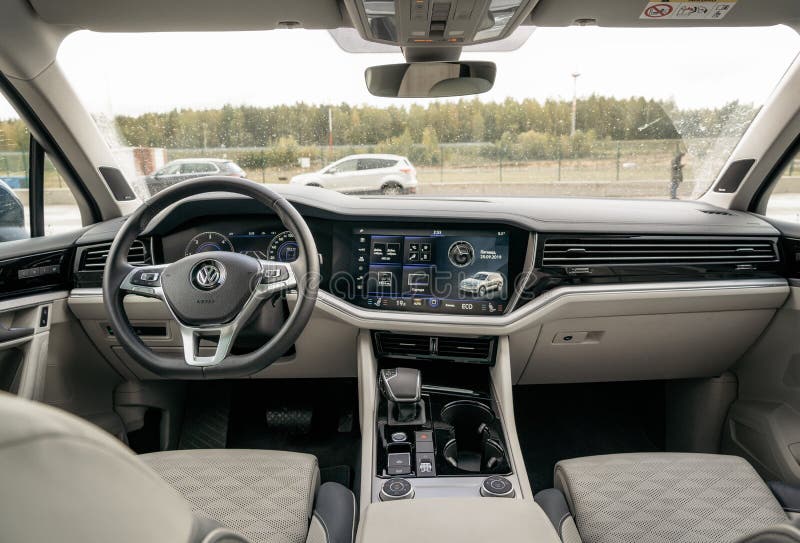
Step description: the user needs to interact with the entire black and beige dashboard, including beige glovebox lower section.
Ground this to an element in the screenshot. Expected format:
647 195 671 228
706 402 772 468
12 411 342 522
56 186 788 383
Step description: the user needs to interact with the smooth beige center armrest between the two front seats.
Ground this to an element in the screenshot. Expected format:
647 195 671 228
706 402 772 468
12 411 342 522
357 498 560 543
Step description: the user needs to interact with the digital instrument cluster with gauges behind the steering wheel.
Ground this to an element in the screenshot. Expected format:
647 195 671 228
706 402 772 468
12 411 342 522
184 230 298 262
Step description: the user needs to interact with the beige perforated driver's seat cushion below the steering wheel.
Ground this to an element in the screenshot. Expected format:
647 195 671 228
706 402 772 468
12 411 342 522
139 449 319 543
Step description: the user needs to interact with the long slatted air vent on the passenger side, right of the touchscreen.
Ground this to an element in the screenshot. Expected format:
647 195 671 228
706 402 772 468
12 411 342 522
542 236 778 268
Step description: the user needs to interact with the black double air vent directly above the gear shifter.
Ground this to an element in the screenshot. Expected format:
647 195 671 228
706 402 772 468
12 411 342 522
373 332 495 363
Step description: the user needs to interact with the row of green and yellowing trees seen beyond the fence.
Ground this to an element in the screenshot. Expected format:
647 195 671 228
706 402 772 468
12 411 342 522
0 95 757 164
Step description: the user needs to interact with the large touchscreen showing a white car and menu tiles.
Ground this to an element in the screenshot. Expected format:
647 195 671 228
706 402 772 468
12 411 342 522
353 228 511 315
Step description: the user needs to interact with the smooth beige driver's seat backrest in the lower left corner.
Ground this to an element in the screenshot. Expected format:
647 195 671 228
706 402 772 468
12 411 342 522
0 393 195 543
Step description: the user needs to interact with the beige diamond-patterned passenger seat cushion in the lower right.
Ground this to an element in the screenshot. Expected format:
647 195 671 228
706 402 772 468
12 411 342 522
534 453 800 543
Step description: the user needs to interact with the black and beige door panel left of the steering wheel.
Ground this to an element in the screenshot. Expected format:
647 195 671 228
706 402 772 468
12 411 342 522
0 231 126 439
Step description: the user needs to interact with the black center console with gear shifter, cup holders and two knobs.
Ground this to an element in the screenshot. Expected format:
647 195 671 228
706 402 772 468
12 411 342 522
362 333 520 502
